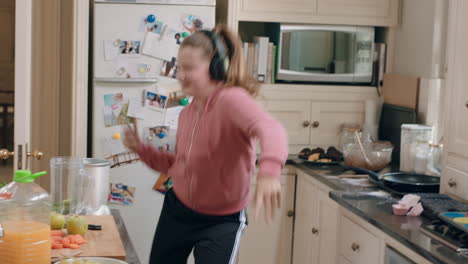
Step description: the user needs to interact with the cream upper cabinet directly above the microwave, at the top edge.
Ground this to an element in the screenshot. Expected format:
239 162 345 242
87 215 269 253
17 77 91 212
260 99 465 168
230 0 399 26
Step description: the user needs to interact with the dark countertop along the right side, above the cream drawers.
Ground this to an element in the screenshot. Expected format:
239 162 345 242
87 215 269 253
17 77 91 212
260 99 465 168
288 157 468 264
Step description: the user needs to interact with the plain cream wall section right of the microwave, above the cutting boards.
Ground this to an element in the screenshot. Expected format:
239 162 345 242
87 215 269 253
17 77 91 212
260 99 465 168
393 0 448 79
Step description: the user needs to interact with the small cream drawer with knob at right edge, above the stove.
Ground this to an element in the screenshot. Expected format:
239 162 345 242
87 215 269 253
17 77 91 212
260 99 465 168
440 166 468 200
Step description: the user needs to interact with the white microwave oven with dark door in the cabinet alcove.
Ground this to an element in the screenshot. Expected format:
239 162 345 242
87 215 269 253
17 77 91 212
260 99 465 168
276 24 375 83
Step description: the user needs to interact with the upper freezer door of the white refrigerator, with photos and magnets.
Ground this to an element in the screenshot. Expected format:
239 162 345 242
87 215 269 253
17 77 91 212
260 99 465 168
93 3 215 79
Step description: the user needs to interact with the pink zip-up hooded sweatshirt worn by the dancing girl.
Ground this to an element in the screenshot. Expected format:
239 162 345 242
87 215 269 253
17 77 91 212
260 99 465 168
138 87 288 215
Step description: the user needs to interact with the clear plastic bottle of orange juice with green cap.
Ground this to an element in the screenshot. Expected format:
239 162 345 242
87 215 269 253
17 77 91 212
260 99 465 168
0 170 51 264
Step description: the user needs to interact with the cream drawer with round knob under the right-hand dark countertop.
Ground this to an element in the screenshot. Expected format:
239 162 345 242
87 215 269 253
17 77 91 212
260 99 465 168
338 215 380 264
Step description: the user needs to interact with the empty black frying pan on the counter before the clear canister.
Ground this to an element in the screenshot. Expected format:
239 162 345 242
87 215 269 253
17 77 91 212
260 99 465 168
382 172 440 193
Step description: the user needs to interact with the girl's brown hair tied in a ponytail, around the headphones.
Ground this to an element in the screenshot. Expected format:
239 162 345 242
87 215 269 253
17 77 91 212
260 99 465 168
181 25 259 96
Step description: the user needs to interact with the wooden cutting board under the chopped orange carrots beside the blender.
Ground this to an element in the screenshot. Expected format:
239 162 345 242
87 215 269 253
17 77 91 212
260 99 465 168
52 215 126 260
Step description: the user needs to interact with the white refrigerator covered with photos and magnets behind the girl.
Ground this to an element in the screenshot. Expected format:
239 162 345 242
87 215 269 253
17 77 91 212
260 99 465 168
89 0 216 263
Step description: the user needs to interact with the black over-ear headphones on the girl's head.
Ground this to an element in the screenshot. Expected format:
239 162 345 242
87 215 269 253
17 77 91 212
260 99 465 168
200 30 229 81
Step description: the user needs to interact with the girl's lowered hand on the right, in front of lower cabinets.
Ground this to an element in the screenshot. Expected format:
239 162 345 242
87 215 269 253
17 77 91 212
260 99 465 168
254 176 281 224
